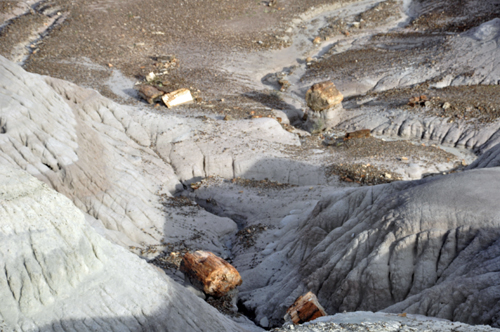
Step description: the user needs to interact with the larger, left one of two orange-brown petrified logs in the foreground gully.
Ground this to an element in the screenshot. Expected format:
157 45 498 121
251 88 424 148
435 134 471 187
180 251 242 297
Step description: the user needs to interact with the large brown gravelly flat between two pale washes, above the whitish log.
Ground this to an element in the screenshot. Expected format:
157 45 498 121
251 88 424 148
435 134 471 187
2 0 348 96
